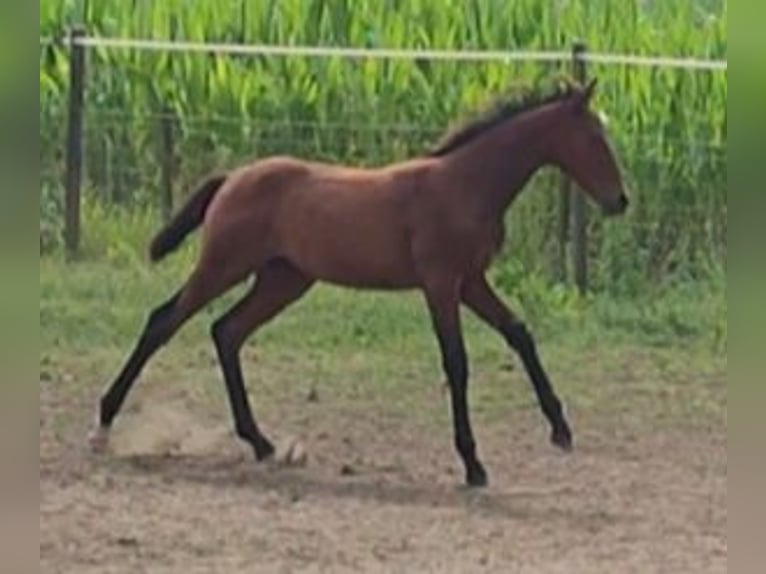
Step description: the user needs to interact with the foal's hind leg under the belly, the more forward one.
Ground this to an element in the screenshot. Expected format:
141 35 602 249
212 260 313 461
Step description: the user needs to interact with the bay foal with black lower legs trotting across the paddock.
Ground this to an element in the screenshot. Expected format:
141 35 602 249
92 81 628 486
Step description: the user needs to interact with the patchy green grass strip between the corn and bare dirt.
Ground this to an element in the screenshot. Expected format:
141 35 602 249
40 243 726 440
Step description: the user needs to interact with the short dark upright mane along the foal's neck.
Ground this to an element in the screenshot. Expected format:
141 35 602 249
426 82 572 157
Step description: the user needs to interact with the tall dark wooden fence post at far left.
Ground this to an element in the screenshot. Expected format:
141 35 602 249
64 28 85 257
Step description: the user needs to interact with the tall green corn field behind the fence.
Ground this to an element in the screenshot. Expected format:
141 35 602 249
40 0 727 294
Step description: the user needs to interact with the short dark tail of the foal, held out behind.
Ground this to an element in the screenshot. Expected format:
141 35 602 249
149 174 227 262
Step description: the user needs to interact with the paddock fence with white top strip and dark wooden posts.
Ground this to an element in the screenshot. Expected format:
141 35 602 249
40 29 727 291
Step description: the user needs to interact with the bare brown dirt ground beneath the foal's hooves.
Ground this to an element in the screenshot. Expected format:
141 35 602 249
40 376 727 573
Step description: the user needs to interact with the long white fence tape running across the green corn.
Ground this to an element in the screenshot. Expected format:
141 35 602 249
73 37 727 71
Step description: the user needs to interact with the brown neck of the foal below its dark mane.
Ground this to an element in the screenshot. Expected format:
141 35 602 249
444 105 555 216
